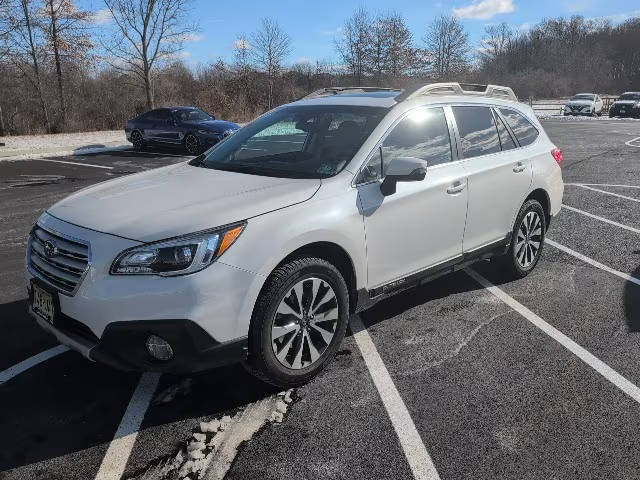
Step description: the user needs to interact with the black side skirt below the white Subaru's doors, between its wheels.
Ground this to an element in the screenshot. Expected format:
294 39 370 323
356 232 512 313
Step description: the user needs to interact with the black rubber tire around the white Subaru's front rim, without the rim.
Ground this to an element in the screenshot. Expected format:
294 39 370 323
245 256 349 388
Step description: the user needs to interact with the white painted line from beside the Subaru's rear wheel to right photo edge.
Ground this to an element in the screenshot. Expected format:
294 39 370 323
464 268 640 403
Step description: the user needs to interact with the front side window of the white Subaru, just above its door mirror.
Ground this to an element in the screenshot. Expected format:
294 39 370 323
356 107 451 183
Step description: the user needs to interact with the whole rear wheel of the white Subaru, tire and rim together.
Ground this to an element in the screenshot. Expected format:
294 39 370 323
501 199 547 278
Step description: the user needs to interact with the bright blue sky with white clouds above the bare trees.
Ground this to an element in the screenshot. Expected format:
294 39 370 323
78 0 640 65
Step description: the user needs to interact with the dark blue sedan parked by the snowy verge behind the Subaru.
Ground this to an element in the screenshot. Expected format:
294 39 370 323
124 107 240 155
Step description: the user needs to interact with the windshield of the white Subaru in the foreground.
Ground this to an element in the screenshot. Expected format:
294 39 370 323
192 105 387 178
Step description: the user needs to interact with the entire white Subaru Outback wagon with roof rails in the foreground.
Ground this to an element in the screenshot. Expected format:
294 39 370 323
26 83 563 386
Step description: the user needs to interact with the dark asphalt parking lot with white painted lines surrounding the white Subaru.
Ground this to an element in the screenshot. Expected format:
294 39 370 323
0 119 640 480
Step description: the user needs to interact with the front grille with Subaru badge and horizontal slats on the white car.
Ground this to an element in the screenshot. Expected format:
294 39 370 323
27 225 89 295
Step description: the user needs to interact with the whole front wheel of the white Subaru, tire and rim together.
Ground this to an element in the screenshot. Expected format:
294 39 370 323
247 257 349 388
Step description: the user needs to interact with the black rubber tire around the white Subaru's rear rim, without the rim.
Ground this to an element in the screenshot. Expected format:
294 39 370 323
499 199 547 279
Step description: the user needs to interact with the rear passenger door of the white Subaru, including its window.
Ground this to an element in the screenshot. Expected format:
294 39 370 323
452 105 532 252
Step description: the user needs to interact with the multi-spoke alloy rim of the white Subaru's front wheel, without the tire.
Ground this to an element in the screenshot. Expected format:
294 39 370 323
271 277 339 370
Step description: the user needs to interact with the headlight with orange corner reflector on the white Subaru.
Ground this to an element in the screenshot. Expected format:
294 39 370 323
110 223 246 277
